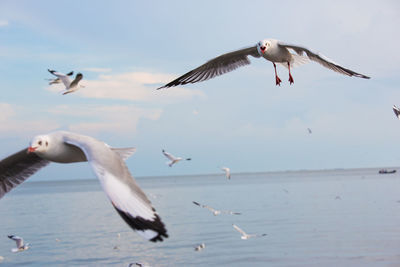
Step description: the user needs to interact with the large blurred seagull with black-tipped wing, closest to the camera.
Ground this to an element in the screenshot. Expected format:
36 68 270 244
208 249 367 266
0 131 168 242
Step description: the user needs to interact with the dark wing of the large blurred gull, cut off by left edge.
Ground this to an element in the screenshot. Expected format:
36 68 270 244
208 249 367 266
0 148 49 198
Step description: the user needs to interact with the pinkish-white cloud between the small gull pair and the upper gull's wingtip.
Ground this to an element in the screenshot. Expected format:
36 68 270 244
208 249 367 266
47 72 205 103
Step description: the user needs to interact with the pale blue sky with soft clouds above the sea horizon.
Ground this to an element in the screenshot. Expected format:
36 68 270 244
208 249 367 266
0 0 400 180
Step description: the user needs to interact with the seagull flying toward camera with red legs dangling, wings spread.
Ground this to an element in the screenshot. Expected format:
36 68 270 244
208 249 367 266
157 39 370 89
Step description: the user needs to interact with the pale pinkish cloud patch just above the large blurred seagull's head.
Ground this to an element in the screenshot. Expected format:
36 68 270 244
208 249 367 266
49 105 162 136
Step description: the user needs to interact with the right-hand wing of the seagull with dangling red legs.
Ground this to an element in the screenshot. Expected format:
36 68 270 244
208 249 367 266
278 42 370 79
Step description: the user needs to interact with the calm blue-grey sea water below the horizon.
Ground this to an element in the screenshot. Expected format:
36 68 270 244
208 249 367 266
0 169 400 267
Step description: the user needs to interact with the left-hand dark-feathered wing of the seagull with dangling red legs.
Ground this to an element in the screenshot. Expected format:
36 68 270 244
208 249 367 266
157 46 260 89
